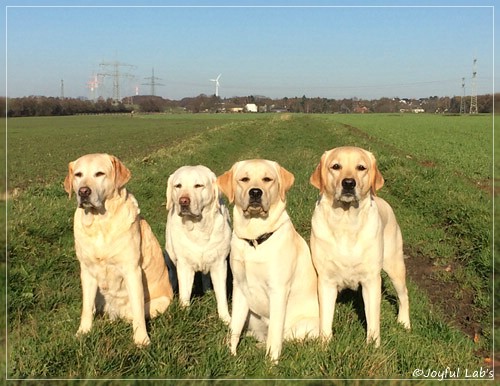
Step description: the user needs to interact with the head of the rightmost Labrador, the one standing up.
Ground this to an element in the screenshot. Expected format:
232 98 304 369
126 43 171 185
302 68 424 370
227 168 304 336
310 146 384 204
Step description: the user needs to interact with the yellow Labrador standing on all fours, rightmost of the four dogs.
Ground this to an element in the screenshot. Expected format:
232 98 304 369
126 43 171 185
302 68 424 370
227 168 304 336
311 147 410 346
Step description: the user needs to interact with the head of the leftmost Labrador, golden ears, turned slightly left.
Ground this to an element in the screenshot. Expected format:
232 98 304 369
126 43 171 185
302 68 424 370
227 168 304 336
64 154 130 211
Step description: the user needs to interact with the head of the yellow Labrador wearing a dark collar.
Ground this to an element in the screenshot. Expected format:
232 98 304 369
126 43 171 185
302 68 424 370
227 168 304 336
217 159 294 217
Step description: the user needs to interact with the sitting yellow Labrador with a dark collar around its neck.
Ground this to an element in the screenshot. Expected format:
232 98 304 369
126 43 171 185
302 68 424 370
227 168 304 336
217 159 319 362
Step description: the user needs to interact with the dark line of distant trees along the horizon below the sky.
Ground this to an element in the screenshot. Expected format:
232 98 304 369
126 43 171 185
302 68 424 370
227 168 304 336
0 94 494 117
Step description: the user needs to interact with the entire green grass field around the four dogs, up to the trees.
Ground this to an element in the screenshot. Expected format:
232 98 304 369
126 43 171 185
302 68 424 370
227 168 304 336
6 114 498 384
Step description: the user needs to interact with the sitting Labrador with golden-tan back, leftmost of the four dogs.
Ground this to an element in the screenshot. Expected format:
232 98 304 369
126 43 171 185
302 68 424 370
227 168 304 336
64 154 173 346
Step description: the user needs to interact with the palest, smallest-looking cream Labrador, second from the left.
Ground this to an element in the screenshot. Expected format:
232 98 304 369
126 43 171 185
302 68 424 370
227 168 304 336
165 165 231 323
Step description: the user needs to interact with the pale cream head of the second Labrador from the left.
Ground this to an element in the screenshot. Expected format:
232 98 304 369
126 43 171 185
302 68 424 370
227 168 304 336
167 165 219 220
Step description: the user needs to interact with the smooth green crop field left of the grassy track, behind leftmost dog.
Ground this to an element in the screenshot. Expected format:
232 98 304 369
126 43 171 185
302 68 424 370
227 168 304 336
1 114 270 190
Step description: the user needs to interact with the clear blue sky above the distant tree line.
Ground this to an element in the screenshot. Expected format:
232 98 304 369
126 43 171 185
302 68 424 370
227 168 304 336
0 0 499 99
